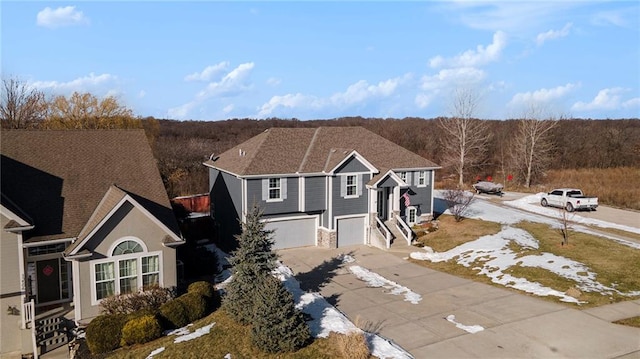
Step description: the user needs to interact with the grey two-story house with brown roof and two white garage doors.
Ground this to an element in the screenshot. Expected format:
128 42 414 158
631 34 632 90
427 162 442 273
204 127 440 252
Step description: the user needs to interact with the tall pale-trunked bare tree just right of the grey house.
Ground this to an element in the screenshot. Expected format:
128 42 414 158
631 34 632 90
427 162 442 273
438 88 490 186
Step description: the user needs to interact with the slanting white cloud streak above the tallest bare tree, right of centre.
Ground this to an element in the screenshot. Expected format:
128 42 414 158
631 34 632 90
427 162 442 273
429 31 507 68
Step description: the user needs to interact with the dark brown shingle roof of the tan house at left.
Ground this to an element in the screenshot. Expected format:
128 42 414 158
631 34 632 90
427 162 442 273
0 129 179 245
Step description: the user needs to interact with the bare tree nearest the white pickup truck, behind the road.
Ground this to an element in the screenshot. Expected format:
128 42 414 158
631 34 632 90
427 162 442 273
512 104 558 188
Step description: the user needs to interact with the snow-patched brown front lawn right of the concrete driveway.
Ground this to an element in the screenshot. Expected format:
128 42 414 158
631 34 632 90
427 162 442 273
411 216 640 308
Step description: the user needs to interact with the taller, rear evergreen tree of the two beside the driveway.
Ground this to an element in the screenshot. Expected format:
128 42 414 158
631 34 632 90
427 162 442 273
223 206 278 324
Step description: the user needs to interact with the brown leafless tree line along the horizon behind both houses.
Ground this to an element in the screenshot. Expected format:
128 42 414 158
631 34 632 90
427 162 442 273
0 79 640 197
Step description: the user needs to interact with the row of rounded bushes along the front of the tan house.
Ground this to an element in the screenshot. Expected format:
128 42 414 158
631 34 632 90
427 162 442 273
86 281 220 354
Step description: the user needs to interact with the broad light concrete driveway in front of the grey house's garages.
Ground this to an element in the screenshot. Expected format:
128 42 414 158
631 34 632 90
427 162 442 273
278 246 640 358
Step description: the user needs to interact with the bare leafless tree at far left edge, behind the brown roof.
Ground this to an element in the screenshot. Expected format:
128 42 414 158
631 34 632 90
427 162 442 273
0 78 47 128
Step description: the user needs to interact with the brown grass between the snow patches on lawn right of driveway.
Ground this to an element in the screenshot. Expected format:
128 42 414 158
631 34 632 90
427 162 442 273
412 216 640 308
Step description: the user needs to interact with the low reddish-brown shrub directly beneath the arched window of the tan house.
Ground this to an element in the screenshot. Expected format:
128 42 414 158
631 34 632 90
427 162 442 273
100 286 175 314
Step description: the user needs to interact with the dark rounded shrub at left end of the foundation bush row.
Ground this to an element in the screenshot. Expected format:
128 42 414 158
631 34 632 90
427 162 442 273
86 314 127 354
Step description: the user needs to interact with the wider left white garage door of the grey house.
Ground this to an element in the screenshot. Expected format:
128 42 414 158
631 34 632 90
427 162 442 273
265 217 317 249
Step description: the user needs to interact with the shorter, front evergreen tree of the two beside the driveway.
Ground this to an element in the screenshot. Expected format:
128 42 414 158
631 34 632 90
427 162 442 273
251 274 311 353
